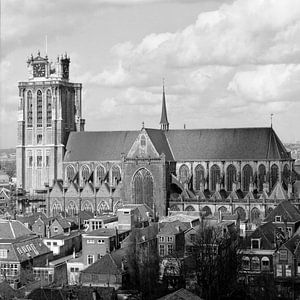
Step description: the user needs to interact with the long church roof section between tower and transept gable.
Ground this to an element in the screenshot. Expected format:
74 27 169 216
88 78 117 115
64 131 139 162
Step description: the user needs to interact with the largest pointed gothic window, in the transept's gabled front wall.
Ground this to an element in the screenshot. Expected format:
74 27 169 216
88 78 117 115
132 169 153 207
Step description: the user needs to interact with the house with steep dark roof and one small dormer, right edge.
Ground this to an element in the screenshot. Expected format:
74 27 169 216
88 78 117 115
264 199 300 238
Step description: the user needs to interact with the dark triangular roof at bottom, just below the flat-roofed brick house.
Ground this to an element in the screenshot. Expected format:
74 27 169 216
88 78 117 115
82 249 126 275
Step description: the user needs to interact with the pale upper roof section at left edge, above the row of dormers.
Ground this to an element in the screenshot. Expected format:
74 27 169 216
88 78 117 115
0 219 34 242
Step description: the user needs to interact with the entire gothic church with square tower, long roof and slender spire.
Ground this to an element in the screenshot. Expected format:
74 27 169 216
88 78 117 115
17 53 296 221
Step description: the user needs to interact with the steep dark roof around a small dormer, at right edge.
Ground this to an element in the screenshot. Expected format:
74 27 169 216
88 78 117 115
264 200 300 223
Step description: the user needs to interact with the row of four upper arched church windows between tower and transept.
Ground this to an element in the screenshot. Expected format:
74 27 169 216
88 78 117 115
65 165 121 185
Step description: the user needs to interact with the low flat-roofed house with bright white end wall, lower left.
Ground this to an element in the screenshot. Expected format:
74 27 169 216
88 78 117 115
43 231 82 257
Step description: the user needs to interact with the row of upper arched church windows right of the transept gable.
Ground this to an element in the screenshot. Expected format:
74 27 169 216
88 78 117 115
179 164 290 191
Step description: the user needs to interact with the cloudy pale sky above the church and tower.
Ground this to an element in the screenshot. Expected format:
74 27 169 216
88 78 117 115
0 0 300 148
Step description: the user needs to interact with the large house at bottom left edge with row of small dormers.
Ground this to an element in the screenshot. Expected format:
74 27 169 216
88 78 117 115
0 220 52 288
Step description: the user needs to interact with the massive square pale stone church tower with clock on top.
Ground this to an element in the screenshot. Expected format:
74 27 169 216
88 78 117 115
16 52 85 194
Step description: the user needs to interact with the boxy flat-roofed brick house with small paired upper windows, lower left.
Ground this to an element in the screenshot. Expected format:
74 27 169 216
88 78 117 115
82 228 130 266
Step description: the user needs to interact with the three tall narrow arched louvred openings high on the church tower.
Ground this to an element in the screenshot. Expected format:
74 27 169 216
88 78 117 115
27 90 52 127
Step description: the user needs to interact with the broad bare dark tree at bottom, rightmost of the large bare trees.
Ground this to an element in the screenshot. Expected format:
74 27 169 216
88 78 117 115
188 223 239 299
